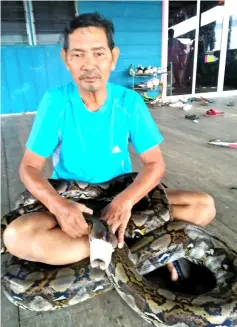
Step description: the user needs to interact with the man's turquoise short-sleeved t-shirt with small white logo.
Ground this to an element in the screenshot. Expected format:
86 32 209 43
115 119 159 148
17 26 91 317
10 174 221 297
26 82 163 183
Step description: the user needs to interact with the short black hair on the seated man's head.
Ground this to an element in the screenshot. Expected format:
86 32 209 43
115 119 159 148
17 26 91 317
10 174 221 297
63 12 114 50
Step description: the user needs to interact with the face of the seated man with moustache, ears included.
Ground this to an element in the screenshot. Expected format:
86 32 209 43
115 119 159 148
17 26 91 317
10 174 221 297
62 27 119 92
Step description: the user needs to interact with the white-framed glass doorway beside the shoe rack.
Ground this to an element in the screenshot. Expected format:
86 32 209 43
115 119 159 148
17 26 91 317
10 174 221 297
162 0 237 96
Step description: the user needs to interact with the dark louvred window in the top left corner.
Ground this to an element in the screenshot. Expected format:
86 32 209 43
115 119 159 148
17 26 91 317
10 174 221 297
1 1 29 45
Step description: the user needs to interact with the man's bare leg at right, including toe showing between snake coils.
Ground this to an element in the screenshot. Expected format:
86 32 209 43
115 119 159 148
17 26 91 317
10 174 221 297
166 189 216 281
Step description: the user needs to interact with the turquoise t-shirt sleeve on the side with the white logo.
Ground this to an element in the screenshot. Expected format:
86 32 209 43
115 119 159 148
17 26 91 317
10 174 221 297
130 94 163 154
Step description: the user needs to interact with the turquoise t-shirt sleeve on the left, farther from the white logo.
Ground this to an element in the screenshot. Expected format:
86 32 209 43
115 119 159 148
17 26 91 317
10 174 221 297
26 92 59 158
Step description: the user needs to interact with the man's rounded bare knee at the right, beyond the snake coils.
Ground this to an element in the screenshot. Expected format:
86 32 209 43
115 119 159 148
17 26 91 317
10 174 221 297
197 193 216 226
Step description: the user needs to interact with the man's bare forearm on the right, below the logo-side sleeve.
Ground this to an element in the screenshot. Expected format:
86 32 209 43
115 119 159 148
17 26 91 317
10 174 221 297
116 163 165 205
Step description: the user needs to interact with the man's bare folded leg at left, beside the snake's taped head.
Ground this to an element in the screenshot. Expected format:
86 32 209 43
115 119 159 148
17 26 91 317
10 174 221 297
3 212 90 265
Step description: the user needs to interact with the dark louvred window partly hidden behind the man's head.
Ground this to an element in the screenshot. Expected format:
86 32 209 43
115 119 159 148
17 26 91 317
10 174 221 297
32 1 76 44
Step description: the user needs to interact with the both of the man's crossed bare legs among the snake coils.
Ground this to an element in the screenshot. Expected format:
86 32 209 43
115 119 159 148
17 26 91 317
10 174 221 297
3 189 216 280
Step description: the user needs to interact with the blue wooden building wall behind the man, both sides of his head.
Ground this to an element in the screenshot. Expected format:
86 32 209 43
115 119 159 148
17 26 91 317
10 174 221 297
1 1 162 114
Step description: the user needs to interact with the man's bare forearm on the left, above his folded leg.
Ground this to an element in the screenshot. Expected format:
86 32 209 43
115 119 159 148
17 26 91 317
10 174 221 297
20 166 62 213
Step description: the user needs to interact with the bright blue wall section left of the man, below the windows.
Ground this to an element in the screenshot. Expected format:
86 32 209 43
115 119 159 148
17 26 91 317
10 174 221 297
1 45 71 114
